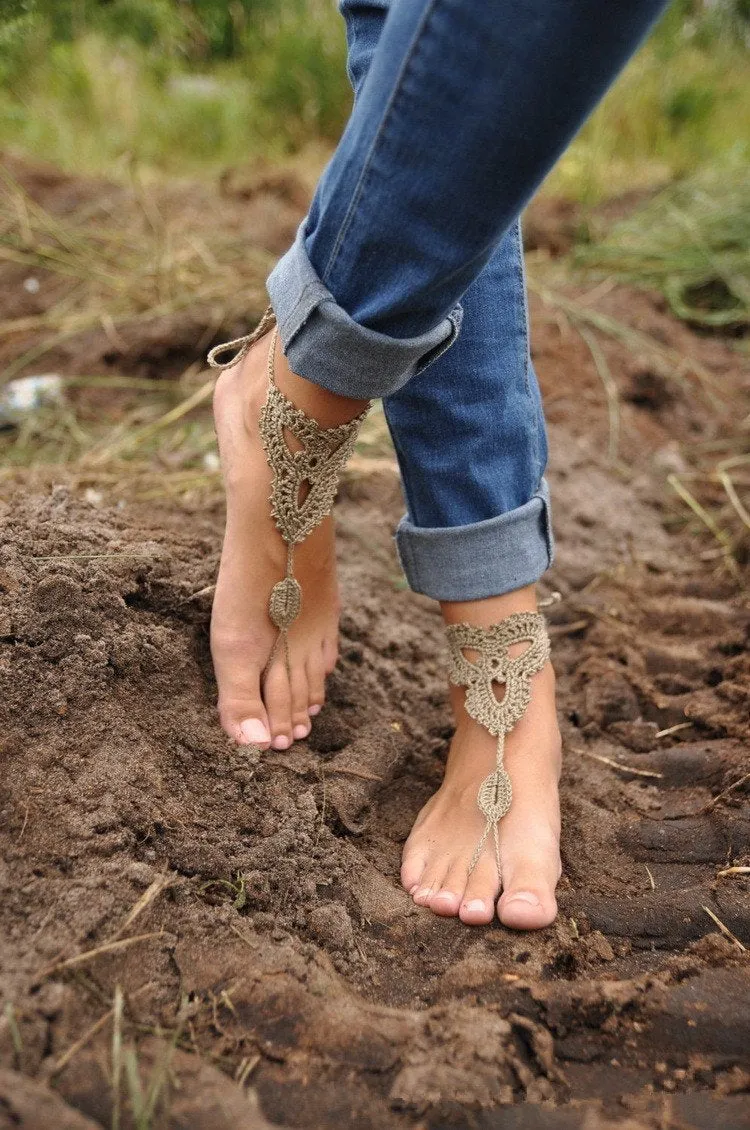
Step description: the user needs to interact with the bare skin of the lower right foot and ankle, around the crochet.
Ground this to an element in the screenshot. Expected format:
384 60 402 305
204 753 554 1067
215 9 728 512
401 586 560 930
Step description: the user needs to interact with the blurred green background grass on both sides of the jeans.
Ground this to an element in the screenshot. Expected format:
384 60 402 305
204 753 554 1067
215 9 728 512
0 0 750 197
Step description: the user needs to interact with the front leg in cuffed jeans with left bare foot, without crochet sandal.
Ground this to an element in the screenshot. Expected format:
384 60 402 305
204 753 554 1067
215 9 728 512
212 0 661 786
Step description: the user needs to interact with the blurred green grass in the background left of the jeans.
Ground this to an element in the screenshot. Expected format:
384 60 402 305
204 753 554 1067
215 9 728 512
0 0 350 176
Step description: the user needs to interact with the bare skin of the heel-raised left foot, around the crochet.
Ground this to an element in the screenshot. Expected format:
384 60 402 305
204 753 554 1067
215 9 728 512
211 336 366 749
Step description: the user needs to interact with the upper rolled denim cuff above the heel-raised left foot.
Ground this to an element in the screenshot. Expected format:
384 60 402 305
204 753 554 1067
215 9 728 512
267 223 462 400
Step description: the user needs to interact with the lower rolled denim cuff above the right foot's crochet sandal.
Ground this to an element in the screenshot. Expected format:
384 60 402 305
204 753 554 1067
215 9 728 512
395 479 555 601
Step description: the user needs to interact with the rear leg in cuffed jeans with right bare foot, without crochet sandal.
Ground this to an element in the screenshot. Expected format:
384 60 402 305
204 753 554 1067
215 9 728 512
384 236 560 929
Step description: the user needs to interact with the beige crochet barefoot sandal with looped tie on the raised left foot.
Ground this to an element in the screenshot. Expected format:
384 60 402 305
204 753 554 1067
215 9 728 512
208 306 367 676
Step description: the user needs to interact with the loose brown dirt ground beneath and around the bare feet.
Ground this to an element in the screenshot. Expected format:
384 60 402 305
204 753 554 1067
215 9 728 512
0 159 750 1130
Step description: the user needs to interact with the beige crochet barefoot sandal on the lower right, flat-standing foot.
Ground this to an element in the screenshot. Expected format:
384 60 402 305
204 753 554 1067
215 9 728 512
447 612 549 875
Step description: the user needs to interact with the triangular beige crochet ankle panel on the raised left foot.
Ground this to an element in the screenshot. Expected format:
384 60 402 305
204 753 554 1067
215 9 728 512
260 382 364 546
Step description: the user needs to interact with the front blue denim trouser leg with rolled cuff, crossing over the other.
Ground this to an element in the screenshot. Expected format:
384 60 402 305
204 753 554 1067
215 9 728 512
269 0 665 398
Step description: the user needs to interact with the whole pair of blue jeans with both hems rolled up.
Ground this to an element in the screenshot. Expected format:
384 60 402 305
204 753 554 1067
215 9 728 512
268 0 665 600
